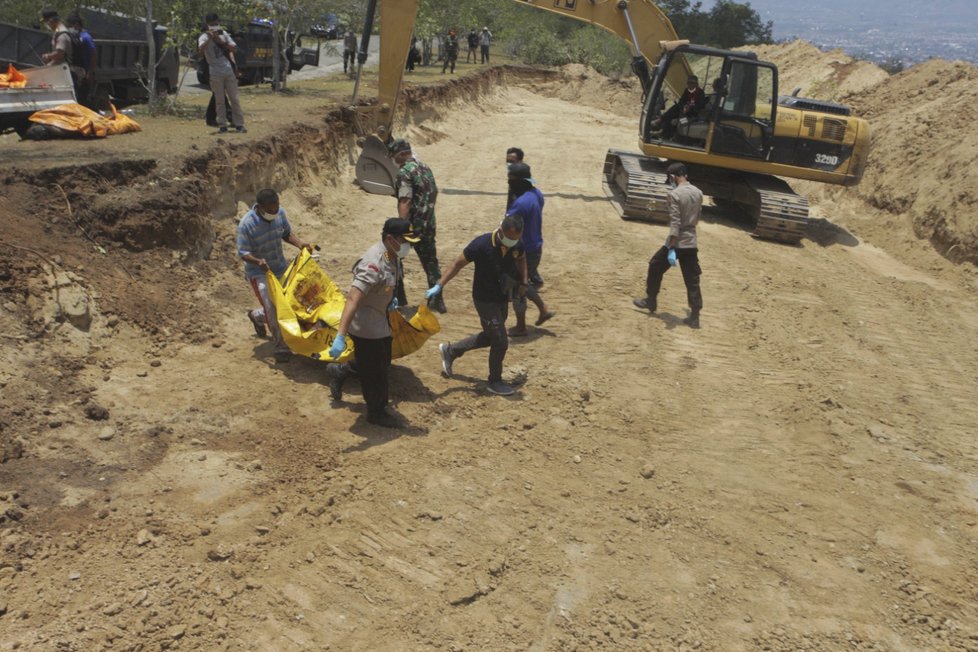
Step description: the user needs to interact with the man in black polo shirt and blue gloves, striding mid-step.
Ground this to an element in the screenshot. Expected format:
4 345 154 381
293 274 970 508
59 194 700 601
427 215 529 396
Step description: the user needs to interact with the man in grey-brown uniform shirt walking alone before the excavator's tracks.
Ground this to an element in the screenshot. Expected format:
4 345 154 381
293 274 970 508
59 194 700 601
632 163 703 328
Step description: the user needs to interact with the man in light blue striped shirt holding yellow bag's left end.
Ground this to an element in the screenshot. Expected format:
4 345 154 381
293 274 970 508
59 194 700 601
238 188 312 362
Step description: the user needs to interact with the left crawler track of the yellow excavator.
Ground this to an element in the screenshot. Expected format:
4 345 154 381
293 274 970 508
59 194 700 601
604 149 669 224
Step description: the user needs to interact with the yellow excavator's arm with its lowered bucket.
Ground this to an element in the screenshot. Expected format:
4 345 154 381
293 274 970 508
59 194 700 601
353 0 687 195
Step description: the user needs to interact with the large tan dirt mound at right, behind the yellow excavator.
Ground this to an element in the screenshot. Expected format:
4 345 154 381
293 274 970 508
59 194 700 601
756 41 978 264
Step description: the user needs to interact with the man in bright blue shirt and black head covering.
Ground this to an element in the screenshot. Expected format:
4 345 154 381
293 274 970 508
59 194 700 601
506 163 557 337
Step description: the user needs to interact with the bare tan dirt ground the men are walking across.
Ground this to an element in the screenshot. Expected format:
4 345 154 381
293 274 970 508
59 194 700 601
0 63 978 651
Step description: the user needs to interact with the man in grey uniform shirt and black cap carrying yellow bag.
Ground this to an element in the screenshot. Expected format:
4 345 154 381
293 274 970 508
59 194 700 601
326 217 418 428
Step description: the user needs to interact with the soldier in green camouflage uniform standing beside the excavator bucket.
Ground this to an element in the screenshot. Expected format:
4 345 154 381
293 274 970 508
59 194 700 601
389 138 447 313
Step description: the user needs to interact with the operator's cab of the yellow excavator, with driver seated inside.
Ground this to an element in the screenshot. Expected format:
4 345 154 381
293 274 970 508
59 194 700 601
642 45 778 159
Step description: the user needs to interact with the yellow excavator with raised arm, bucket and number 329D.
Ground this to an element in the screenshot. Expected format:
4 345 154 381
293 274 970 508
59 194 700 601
346 0 869 243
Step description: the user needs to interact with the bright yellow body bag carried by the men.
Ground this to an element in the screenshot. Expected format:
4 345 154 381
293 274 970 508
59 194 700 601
266 249 441 362
